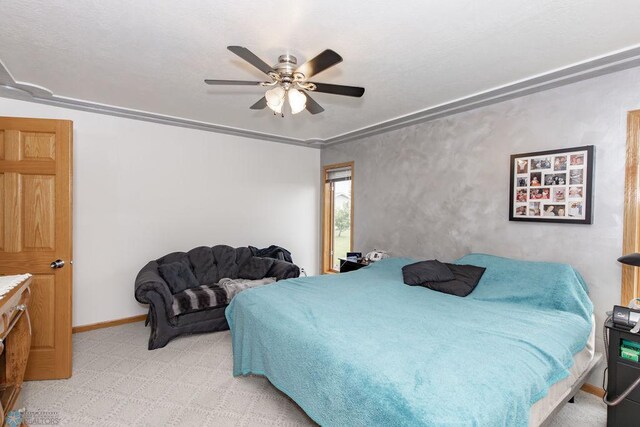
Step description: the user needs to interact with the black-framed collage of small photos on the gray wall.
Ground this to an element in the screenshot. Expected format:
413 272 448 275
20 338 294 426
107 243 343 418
509 145 595 224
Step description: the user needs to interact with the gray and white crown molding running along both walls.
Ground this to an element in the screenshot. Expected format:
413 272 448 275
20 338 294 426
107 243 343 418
0 46 640 148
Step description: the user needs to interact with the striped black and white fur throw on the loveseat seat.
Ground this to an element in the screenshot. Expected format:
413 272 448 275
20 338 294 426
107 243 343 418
171 277 276 317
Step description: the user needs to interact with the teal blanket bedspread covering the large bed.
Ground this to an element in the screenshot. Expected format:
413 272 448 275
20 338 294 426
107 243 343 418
226 254 593 426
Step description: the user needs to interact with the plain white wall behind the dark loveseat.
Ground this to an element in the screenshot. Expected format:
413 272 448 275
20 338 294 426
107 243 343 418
0 98 320 325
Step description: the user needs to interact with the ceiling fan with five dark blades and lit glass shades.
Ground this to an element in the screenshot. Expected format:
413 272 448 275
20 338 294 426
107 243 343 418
204 46 364 117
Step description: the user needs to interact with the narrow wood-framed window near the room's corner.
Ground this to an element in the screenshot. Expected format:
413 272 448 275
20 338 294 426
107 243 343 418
322 162 353 273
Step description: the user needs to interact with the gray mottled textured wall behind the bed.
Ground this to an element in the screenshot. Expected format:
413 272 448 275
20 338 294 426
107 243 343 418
322 68 640 384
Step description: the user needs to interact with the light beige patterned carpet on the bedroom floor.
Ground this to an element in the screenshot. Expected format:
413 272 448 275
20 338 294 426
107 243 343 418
23 323 606 427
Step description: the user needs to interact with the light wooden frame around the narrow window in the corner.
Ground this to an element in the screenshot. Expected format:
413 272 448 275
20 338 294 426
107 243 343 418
321 161 355 274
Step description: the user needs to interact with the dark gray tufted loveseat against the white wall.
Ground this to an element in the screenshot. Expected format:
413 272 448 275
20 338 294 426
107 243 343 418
135 245 300 350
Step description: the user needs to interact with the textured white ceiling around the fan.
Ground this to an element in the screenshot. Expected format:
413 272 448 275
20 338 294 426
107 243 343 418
0 0 640 140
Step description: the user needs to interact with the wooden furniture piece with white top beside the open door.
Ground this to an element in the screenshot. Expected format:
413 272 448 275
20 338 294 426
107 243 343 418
0 275 31 425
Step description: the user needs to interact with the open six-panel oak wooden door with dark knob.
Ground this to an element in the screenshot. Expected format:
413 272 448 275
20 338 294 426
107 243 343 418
0 117 73 380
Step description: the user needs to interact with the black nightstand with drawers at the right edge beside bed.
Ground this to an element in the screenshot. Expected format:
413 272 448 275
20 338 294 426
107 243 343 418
605 321 640 427
